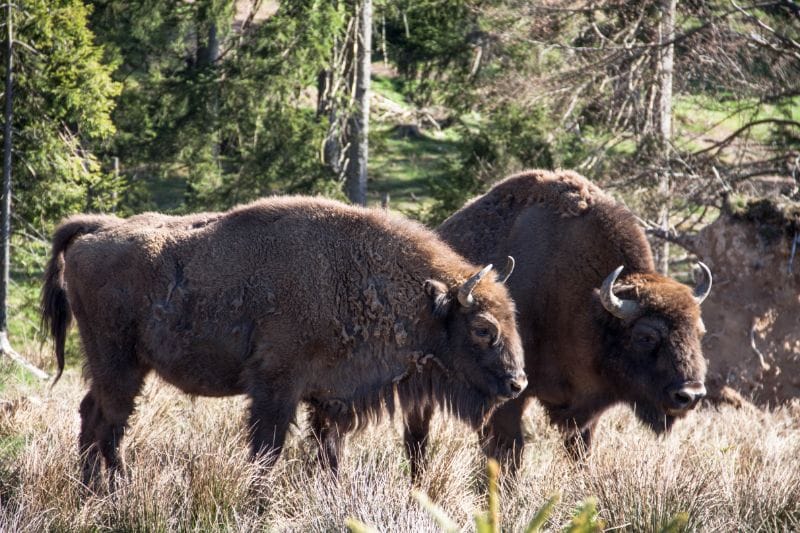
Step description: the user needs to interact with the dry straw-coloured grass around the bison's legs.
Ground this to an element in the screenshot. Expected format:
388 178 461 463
0 372 800 531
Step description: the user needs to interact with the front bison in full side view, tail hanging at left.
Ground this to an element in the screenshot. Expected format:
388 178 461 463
42 197 527 484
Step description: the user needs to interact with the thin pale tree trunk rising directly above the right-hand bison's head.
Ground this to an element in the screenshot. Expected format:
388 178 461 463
656 0 677 275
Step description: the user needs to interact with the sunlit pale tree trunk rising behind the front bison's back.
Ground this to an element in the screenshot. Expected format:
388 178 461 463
345 0 372 205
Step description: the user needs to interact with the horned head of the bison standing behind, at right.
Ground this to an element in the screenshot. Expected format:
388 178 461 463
598 263 711 433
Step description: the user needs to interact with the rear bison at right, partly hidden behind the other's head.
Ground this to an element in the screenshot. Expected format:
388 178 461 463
406 171 711 464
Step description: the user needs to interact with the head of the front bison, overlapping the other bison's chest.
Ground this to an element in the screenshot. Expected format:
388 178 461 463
425 257 528 422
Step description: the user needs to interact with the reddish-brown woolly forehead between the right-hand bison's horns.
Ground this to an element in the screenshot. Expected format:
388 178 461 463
617 274 700 324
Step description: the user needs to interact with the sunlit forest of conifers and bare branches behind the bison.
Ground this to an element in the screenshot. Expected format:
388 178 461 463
6 0 800 378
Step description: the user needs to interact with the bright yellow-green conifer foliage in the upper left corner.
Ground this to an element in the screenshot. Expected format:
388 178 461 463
13 0 123 225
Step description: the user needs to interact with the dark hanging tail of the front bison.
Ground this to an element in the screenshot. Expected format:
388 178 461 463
41 215 119 385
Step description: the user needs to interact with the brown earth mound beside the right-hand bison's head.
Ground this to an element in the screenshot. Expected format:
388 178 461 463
693 199 800 405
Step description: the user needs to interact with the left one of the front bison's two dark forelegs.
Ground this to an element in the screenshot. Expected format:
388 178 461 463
250 384 299 466
